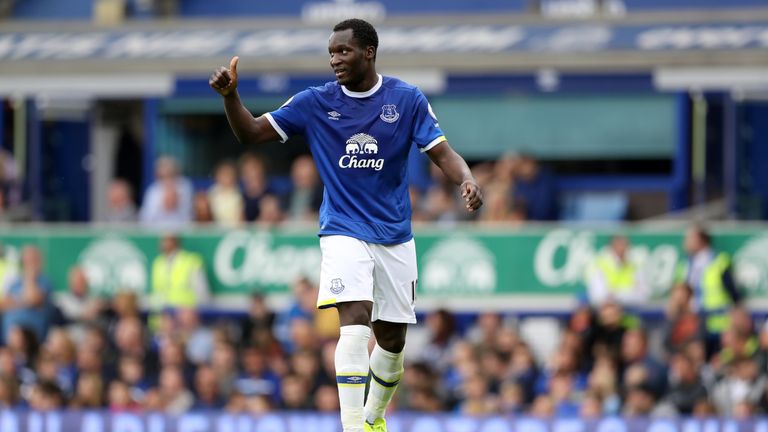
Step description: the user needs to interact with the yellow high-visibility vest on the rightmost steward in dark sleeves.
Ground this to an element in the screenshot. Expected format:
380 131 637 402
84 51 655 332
680 253 733 333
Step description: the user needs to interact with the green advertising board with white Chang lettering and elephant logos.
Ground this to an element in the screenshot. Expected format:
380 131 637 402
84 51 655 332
0 226 768 299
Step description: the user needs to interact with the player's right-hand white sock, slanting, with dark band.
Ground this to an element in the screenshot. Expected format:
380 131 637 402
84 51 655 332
365 344 403 424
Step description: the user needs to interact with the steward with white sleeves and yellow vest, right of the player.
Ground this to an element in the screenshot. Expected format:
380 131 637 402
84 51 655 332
585 235 649 308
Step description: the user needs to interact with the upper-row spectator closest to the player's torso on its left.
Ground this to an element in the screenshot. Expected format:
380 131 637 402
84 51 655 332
283 155 323 222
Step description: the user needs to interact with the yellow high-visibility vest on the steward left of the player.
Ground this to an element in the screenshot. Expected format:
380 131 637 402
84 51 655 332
152 250 203 307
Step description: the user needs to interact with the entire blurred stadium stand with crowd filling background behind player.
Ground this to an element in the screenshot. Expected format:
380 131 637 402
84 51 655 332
0 0 768 432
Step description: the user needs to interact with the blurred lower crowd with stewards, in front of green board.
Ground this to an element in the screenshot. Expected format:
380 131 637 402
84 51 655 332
0 223 768 418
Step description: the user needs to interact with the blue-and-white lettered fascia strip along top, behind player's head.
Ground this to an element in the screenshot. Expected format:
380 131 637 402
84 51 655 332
0 22 768 60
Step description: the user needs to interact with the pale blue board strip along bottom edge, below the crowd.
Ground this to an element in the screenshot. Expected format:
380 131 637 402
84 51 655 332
0 411 768 432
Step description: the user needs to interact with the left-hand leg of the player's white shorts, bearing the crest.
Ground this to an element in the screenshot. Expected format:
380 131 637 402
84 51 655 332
317 235 373 308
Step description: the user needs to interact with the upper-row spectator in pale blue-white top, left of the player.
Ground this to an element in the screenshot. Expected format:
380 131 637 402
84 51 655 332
139 156 193 227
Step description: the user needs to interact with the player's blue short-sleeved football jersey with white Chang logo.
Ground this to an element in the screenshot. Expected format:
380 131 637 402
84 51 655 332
265 75 445 244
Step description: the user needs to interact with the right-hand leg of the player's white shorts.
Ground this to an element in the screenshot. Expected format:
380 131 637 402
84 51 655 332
371 239 418 324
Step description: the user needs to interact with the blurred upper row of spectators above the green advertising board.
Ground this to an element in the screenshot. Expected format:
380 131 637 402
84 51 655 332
99 154 558 228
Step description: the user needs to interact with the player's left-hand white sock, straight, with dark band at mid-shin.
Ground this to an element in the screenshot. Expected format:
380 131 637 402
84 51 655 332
335 325 371 432
